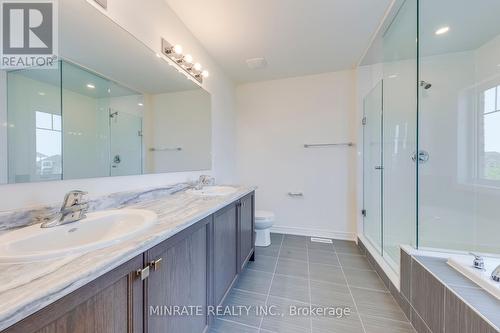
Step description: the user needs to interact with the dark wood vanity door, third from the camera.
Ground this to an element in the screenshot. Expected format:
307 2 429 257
214 204 238 305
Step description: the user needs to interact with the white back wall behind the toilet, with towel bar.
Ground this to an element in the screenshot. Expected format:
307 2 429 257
236 71 355 239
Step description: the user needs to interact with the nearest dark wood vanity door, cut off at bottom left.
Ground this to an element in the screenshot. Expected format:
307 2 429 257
3 255 143 333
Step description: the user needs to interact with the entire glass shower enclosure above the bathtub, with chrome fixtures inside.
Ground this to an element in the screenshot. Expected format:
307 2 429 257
358 0 500 274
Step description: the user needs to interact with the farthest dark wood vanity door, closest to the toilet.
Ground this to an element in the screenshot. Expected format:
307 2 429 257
239 194 255 269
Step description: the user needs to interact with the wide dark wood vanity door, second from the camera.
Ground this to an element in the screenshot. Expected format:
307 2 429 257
145 218 211 333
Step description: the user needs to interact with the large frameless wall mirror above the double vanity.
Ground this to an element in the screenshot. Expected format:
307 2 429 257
0 0 212 184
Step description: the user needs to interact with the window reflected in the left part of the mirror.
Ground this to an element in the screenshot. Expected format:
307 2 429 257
35 111 62 179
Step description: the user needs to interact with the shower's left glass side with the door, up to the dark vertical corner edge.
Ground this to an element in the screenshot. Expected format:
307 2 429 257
359 1 417 271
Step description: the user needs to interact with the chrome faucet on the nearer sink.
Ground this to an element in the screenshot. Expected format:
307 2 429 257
41 191 89 228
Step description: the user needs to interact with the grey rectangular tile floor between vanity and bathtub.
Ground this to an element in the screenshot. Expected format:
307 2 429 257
211 234 415 333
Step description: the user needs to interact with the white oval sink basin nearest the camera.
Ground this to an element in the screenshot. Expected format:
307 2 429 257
0 209 157 263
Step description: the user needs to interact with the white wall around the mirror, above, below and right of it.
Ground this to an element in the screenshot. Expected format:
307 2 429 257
0 0 235 211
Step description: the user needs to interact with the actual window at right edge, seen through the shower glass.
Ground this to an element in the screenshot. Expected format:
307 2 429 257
479 85 500 181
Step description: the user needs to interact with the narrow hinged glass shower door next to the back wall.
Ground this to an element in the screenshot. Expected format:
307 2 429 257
363 81 383 253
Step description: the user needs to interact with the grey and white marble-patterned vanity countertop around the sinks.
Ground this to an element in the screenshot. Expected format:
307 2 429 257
0 186 255 330
